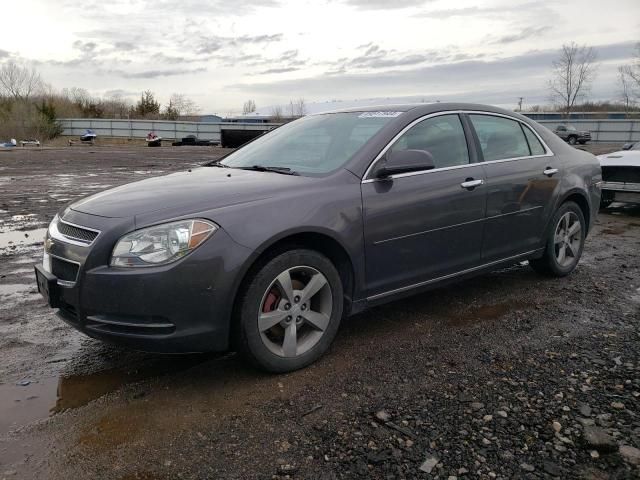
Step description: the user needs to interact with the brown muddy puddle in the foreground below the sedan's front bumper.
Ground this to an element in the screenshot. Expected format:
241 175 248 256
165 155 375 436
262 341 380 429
0 355 211 438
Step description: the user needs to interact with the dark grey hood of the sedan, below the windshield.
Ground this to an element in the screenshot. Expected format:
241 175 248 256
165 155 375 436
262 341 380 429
71 167 312 218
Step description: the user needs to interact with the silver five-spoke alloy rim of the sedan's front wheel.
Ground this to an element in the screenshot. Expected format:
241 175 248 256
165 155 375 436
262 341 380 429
258 266 333 358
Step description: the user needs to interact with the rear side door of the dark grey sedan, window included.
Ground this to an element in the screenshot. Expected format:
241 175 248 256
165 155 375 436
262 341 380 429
468 114 561 263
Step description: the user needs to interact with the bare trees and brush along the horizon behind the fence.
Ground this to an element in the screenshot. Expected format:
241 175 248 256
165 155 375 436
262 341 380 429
0 42 640 140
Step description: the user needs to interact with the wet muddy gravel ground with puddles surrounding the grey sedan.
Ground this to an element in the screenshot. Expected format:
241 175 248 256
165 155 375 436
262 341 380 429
0 146 640 480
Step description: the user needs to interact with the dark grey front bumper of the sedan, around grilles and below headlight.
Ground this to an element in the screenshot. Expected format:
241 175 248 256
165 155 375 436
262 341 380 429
37 211 250 353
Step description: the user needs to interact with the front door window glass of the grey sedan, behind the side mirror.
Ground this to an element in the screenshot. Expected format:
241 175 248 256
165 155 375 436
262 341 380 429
390 114 469 168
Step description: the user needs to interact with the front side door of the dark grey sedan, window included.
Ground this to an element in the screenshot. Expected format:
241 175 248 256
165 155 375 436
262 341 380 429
362 114 486 298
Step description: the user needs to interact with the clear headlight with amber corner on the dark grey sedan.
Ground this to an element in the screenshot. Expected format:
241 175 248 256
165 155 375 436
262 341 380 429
111 220 218 267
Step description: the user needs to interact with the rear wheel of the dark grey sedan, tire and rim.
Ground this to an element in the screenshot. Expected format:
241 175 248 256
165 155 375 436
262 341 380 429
529 202 586 277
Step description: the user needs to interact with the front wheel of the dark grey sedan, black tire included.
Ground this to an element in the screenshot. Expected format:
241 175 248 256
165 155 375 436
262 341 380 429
234 249 344 373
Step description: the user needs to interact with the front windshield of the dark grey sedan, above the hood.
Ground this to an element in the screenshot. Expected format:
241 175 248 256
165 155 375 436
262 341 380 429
220 112 401 175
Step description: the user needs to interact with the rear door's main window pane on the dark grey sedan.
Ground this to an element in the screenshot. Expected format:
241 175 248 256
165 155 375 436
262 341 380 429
469 115 531 162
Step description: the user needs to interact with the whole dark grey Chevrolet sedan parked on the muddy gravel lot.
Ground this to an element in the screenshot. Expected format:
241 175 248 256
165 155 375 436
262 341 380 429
35 103 601 372
